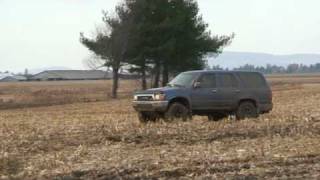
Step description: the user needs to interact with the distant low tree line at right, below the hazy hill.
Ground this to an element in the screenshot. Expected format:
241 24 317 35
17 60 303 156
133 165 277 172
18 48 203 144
208 63 320 74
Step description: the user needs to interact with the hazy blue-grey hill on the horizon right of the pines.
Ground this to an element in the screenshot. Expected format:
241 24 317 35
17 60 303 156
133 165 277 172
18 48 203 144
208 51 320 68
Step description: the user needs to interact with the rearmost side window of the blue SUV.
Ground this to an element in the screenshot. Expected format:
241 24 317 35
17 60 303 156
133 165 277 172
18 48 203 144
238 73 266 88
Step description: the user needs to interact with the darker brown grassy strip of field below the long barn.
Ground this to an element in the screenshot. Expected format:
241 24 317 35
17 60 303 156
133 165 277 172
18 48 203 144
0 81 139 109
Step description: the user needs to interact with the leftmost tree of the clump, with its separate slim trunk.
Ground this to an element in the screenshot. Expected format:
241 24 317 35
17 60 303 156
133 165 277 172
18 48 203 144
80 4 130 98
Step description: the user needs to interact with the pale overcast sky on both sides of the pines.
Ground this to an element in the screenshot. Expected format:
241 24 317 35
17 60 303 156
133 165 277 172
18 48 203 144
0 0 320 72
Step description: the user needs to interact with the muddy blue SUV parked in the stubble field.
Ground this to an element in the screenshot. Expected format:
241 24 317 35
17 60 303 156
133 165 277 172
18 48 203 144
133 71 273 123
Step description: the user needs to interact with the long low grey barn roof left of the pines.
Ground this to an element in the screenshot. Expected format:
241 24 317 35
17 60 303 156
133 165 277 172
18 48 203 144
32 70 110 80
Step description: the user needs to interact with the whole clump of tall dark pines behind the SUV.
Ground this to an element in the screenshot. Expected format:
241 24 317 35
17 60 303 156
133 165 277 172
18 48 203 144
80 0 233 98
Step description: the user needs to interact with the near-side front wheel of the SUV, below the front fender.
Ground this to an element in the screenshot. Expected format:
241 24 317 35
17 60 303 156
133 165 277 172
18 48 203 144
164 102 190 121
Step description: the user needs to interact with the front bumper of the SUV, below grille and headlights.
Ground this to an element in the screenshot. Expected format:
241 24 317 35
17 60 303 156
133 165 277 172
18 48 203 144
132 101 169 112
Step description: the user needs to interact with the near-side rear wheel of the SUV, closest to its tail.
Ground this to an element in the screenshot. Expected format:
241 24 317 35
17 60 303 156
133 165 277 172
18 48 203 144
236 101 259 120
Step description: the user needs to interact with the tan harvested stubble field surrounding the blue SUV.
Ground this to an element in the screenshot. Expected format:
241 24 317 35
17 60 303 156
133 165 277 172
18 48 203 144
0 76 320 180
